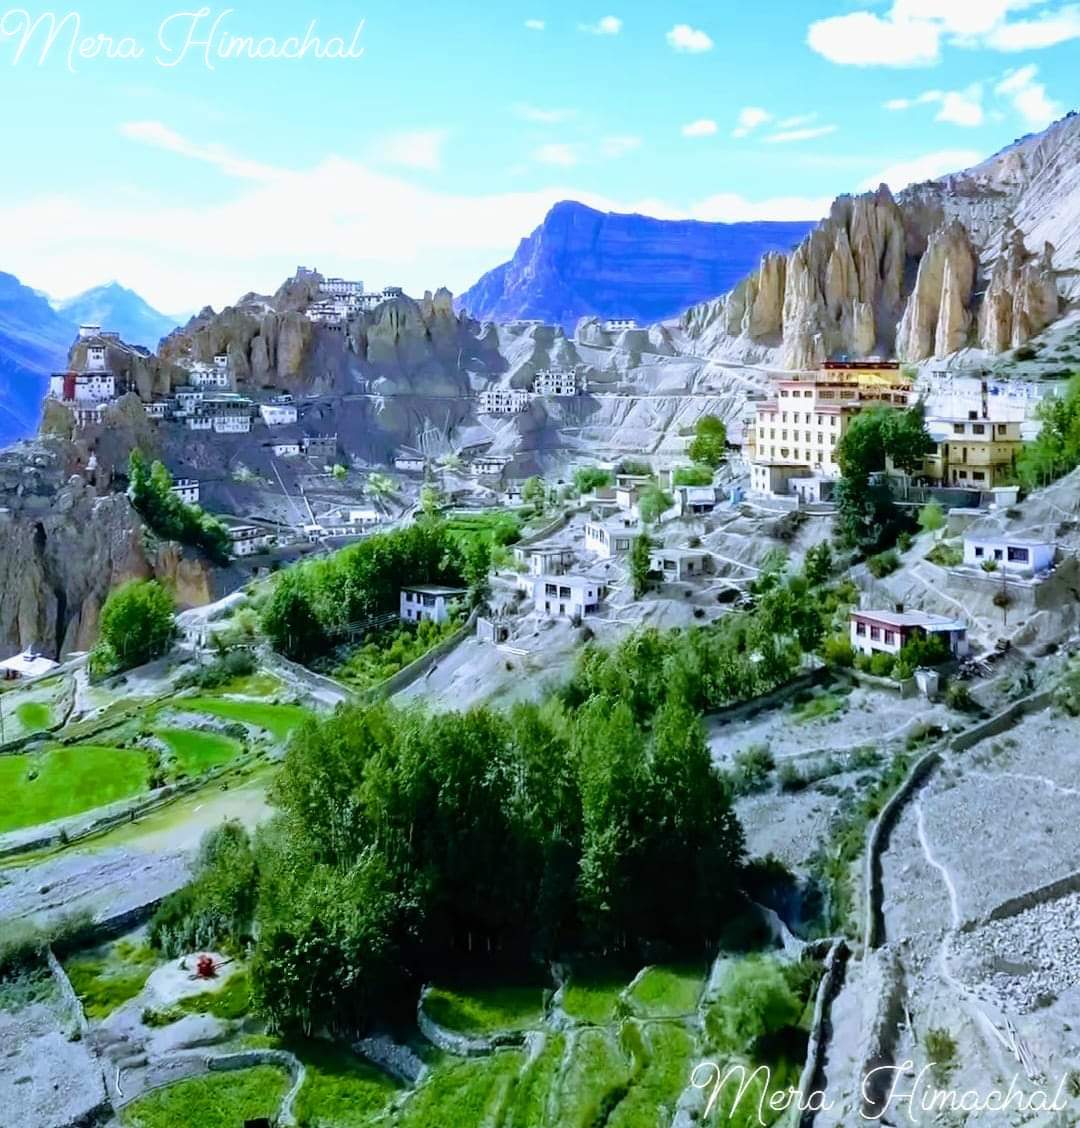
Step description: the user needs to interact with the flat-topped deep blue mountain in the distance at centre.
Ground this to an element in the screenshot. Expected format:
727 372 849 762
456 200 814 331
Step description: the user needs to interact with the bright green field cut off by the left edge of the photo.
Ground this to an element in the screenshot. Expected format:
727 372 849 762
0 744 147 832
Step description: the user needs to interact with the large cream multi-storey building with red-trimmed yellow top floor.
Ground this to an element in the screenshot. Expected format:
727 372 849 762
744 361 912 493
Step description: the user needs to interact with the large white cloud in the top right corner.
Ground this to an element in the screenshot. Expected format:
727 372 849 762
807 0 1080 67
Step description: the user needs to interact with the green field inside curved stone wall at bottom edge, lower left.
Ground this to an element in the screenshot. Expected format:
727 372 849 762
121 1065 289 1128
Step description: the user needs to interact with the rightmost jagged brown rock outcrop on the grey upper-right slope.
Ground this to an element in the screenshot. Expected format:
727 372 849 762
978 224 1060 352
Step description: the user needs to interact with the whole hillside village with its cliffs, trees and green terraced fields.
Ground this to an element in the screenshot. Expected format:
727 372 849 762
0 118 1080 1128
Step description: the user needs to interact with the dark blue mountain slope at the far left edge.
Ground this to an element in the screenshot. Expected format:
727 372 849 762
0 272 74 447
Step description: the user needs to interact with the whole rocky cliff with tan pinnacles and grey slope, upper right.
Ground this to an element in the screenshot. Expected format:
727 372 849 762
681 115 1080 369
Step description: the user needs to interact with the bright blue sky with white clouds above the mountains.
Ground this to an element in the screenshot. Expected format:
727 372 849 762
0 0 1080 314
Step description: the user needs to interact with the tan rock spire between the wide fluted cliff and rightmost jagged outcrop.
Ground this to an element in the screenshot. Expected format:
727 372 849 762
896 220 976 361
